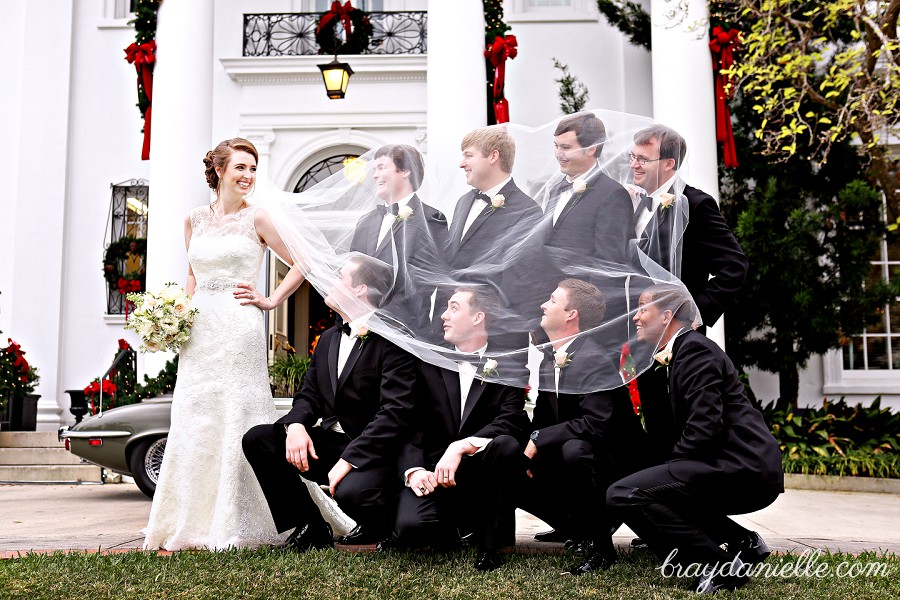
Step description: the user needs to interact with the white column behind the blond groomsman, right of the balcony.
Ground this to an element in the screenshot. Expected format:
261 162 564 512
425 0 487 197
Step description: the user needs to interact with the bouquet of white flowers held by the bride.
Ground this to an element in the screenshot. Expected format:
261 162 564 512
125 283 197 352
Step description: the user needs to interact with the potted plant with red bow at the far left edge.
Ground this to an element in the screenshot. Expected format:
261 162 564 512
0 339 40 431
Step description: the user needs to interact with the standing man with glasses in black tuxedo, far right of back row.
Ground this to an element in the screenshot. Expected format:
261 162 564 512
630 125 748 326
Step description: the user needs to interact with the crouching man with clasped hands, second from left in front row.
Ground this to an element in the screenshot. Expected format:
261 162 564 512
396 286 528 571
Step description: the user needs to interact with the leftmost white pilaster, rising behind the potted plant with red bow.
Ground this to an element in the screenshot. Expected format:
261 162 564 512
2 1 73 430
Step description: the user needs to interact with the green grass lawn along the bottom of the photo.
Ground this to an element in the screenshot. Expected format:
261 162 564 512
0 550 900 600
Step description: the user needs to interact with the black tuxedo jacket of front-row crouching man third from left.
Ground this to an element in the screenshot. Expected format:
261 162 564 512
532 337 646 472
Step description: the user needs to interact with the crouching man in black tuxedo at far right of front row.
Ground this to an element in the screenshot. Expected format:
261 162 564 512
607 284 784 593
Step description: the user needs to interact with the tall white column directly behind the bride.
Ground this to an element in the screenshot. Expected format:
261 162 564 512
145 1 214 375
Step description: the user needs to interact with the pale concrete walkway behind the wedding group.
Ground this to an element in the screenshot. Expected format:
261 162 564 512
0 483 900 558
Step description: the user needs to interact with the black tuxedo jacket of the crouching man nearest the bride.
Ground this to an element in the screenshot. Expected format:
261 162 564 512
276 327 417 468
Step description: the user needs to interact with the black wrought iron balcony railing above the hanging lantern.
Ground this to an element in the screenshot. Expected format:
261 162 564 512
244 11 428 56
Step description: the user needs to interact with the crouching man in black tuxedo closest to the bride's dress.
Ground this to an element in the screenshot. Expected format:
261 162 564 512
243 255 416 552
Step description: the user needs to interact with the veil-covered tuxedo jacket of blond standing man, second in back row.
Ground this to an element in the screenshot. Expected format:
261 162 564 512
435 179 546 331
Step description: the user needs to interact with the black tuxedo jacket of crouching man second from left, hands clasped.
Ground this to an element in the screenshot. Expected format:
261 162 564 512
399 356 530 473
